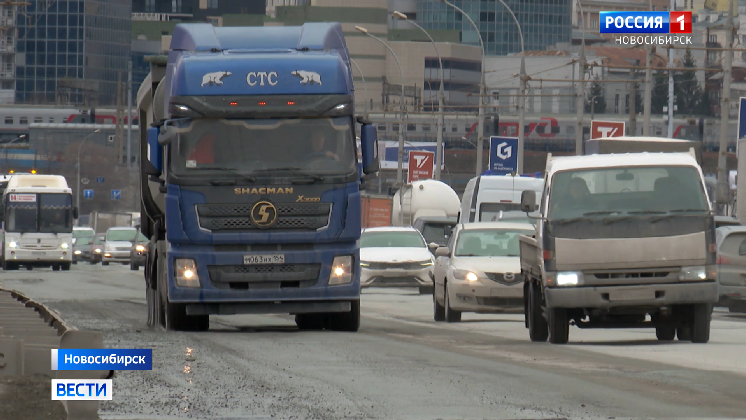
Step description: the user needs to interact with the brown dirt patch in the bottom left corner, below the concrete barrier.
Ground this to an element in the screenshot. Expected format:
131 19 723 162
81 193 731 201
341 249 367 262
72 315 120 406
0 375 67 420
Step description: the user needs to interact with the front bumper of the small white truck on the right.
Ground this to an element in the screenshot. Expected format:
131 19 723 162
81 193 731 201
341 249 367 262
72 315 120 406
544 281 719 308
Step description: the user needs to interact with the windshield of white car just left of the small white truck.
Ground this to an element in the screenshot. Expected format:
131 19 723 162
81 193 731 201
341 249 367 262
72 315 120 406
454 229 534 257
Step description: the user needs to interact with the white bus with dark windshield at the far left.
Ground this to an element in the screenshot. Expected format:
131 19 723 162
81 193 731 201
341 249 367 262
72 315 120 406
2 174 77 270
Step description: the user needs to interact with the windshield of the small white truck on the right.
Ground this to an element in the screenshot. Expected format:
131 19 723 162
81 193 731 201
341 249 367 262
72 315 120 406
549 166 709 221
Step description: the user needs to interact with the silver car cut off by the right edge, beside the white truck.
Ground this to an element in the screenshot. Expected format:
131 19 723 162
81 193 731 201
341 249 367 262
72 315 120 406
716 226 746 313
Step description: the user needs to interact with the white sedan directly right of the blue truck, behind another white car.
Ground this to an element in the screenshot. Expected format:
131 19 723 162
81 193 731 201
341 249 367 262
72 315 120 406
360 227 433 294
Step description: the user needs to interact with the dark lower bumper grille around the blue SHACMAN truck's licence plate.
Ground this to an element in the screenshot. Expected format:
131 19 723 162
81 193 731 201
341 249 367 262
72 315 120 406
207 264 321 289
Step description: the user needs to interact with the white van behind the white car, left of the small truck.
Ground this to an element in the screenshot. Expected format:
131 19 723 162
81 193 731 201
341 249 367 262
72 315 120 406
458 175 544 223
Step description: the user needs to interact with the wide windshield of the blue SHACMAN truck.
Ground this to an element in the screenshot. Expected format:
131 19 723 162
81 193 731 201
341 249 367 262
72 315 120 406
171 117 358 177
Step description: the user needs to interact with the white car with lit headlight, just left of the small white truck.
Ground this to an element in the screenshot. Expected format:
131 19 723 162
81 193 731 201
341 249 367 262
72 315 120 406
433 222 535 322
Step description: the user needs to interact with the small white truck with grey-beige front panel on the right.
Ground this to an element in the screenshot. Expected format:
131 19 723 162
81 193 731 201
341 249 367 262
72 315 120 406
520 153 718 344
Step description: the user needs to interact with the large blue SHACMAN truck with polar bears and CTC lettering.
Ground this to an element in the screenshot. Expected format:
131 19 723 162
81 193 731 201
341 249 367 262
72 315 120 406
137 23 379 331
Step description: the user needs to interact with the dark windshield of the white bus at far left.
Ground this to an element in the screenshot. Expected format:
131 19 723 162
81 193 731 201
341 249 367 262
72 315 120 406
5 193 73 233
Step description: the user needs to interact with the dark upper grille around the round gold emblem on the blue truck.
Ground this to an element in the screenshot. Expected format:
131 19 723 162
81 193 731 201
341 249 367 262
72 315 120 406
197 203 332 232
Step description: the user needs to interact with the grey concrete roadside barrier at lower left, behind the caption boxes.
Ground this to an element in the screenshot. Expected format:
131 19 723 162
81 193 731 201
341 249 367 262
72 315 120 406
0 288 114 420
